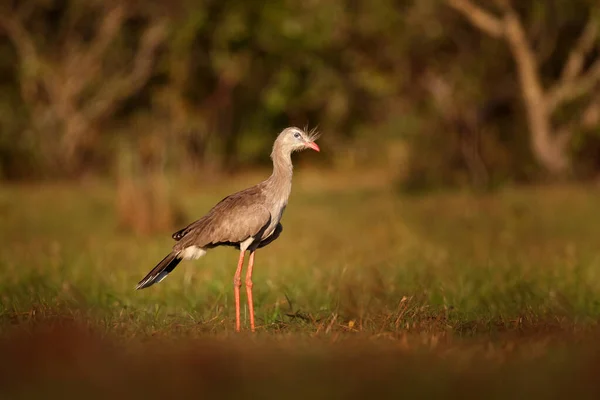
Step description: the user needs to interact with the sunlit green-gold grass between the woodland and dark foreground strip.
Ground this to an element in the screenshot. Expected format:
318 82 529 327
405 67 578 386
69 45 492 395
0 177 600 335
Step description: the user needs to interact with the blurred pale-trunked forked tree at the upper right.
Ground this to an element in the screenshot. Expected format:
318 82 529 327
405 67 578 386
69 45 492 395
447 0 600 176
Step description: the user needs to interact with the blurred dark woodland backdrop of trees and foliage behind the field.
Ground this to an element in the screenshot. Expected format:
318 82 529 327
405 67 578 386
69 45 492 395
0 0 600 190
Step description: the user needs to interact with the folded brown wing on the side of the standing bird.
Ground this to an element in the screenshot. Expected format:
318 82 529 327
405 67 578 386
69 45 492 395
173 187 271 250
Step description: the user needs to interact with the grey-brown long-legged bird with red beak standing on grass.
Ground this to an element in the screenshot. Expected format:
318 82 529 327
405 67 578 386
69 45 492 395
136 126 321 332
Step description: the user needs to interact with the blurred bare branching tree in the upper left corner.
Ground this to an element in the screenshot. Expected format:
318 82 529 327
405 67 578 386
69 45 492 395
0 0 166 173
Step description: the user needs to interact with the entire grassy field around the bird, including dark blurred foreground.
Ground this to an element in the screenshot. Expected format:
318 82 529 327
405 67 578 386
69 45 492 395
0 174 600 399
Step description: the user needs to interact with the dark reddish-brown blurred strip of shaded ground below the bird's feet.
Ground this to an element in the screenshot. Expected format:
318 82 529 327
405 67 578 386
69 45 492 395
0 318 600 399
